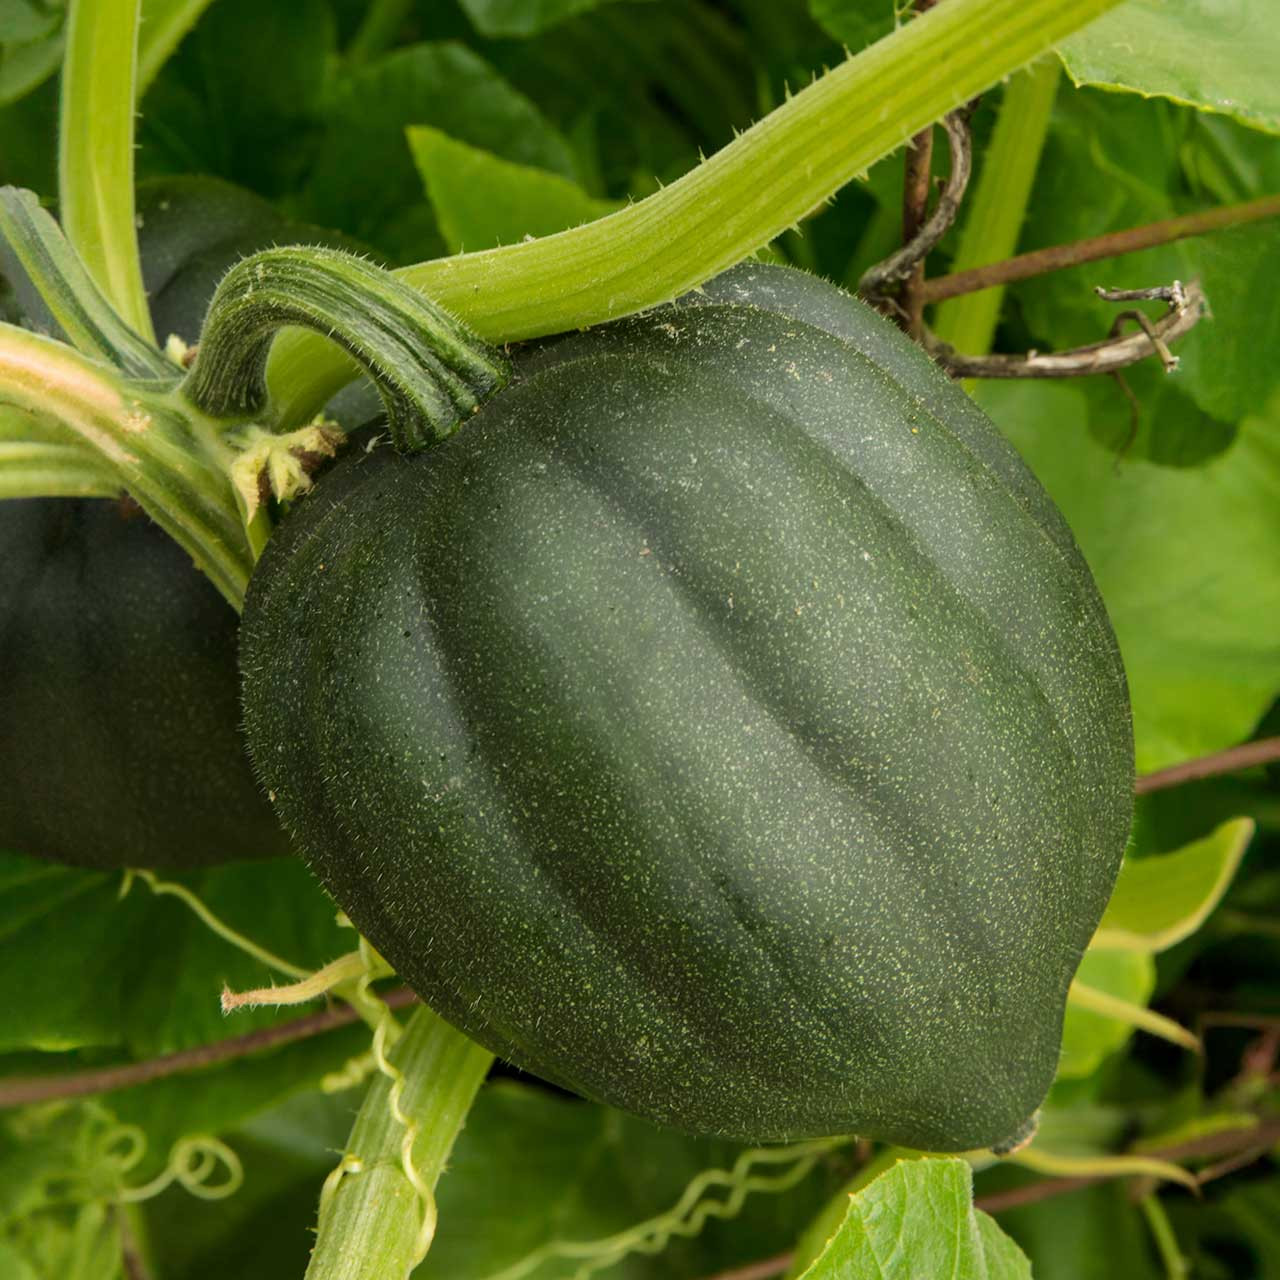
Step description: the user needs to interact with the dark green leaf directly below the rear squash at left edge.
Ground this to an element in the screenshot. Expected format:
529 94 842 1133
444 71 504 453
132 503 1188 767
0 854 352 1057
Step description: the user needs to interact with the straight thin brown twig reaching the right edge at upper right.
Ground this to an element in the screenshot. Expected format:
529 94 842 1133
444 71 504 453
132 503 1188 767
920 195 1280 303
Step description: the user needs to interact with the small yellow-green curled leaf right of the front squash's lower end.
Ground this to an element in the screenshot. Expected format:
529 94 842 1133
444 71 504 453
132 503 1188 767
1094 818 1254 952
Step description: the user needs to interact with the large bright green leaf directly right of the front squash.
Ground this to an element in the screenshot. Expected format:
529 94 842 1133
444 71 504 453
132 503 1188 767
978 373 1280 773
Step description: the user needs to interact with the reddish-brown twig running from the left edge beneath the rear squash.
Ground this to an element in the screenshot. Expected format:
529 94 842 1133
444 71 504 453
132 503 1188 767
0 987 417 1108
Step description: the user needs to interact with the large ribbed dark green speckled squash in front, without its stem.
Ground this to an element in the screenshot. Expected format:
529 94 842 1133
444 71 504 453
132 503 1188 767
242 266 1133 1151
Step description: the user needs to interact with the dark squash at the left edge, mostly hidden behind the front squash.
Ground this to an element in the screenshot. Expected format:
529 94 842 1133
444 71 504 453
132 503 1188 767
0 178 355 867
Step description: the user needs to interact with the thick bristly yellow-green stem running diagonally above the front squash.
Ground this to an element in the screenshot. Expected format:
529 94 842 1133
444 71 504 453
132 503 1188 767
270 0 1116 424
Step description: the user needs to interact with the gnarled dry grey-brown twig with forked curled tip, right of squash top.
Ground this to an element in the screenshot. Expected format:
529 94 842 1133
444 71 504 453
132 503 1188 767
922 280 1207 378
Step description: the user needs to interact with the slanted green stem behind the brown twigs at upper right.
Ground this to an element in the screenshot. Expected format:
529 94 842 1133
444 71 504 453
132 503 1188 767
933 58 1062 356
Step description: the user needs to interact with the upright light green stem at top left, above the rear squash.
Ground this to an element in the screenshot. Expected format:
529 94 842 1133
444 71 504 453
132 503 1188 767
58 0 155 340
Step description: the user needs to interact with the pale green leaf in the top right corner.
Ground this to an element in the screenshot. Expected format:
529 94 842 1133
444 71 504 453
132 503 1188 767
1062 0 1280 133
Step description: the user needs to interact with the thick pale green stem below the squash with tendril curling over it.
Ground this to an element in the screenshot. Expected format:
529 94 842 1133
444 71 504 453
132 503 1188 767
306 1006 493 1280
